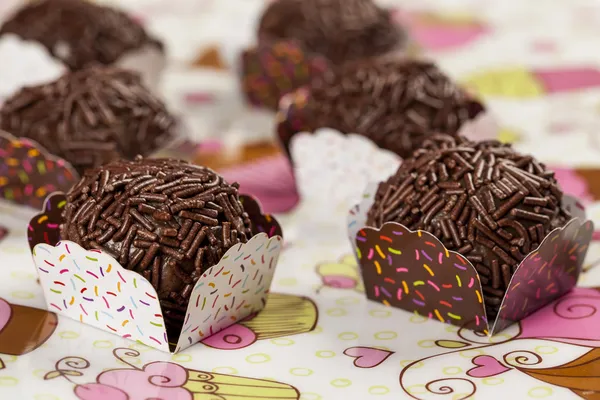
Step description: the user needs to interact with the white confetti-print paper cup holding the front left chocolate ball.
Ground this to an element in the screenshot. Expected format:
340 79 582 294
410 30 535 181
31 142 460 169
28 193 283 353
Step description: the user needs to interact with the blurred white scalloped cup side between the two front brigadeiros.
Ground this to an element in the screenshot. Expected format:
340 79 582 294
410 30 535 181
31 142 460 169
290 128 401 229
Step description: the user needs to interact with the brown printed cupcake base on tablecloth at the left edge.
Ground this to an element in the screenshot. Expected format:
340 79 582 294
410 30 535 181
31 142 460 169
0 299 58 356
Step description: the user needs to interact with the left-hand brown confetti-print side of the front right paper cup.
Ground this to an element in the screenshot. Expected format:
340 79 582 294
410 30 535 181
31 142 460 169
356 222 489 334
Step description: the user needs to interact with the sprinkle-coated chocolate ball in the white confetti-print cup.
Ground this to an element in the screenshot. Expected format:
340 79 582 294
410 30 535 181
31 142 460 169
60 157 251 339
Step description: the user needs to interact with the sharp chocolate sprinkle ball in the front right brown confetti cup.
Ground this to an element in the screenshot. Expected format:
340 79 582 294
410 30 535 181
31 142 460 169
367 135 570 319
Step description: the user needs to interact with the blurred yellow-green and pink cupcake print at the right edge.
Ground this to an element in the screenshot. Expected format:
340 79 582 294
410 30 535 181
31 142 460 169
462 66 600 99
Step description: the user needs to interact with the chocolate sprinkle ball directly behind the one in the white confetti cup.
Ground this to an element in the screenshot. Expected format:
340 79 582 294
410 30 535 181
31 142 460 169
0 66 176 173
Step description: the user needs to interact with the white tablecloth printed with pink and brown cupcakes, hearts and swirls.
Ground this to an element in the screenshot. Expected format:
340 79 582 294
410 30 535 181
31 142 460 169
0 0 600 400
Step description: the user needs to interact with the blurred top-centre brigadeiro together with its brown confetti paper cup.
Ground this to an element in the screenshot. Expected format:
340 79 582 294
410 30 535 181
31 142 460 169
241 0 407 111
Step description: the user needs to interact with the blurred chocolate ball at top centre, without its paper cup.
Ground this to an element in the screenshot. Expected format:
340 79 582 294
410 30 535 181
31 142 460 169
258 0 406 64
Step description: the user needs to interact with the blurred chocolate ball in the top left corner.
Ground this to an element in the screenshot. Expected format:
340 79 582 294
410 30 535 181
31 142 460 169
0 0 162 70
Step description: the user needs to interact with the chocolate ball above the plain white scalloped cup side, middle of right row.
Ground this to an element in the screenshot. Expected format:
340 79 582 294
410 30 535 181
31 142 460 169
278 59 484 157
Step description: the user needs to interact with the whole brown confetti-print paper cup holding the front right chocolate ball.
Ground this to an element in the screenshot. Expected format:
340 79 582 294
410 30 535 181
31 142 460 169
348 184 594 335
